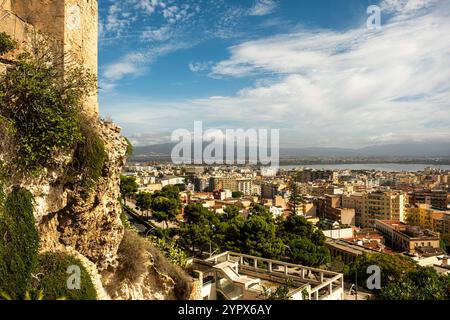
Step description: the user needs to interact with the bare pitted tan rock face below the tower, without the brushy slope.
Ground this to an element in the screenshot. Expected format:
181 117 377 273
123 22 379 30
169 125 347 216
0 122 127 299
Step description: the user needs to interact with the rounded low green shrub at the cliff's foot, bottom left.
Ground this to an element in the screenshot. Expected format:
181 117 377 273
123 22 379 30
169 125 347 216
33 253 97 300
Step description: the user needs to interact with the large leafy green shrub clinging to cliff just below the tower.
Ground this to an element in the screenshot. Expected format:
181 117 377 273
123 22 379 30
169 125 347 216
0 37 95 171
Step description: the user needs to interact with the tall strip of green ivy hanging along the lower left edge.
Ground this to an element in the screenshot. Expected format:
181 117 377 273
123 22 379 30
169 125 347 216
0 188 39 299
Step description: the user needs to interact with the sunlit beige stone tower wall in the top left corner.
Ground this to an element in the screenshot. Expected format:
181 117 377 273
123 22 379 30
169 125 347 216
0 0 98 114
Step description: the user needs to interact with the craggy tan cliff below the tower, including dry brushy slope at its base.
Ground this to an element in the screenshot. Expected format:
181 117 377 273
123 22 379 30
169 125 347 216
0 116 191 300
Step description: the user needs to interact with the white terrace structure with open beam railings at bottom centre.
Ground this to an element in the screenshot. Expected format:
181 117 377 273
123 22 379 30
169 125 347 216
191 252 344 300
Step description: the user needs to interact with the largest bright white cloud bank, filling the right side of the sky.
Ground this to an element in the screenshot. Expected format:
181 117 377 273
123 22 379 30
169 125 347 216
196 1 450 146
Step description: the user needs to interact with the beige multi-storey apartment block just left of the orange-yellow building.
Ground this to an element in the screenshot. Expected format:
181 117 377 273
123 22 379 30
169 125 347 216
361 191 406 227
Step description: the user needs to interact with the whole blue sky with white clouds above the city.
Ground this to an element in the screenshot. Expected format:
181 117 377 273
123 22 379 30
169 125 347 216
99 0 450 147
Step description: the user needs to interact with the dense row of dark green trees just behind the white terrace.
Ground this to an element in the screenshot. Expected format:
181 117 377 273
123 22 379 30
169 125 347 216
179 204 330 266
